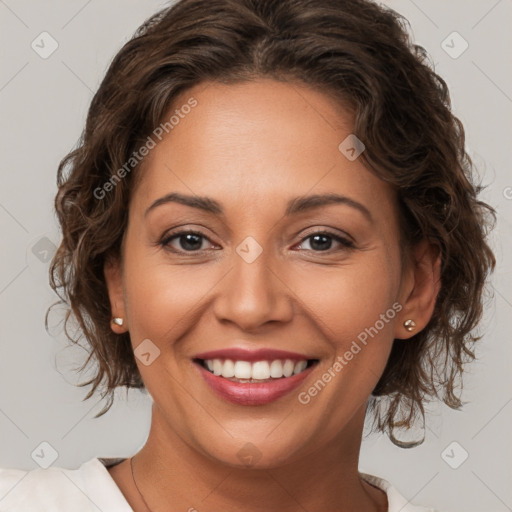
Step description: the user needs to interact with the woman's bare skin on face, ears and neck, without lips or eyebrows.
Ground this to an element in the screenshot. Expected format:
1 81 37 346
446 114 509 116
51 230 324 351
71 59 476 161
105 79 440 512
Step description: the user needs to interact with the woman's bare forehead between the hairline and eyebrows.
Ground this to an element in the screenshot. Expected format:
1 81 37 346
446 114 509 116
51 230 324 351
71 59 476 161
135 79 394 222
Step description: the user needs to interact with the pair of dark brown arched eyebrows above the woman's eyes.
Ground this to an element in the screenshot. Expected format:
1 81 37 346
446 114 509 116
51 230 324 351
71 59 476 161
144 192 374 223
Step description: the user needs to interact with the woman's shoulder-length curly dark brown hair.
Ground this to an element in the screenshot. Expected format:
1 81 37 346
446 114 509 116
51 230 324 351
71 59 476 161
47 0 496 442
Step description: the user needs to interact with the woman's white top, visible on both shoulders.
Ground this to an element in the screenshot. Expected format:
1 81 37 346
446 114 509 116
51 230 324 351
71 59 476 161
0 457 436 512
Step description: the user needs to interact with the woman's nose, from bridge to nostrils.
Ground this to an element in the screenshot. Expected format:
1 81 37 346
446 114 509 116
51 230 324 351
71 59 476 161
214 251 293 331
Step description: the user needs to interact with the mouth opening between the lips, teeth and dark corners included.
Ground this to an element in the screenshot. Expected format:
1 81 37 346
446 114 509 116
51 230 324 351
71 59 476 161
194 359 318 384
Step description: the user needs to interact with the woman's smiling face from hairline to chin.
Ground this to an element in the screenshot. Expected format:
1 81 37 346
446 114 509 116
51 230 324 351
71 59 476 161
106 79 435 467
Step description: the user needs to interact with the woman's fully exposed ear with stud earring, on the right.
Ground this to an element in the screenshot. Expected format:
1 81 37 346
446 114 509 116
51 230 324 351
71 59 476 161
395 239 441 339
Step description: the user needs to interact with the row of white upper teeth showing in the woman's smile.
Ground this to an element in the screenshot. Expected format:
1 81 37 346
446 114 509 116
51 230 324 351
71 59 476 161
205 359 308 380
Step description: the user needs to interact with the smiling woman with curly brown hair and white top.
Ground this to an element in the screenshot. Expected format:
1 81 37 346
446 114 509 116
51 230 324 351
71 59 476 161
0 0 495 512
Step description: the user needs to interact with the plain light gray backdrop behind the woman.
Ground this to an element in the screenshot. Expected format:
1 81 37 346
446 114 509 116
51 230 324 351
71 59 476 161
0 0 512 512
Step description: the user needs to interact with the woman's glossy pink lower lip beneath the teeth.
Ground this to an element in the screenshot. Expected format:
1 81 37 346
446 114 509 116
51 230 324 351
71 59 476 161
196 363 315 405
